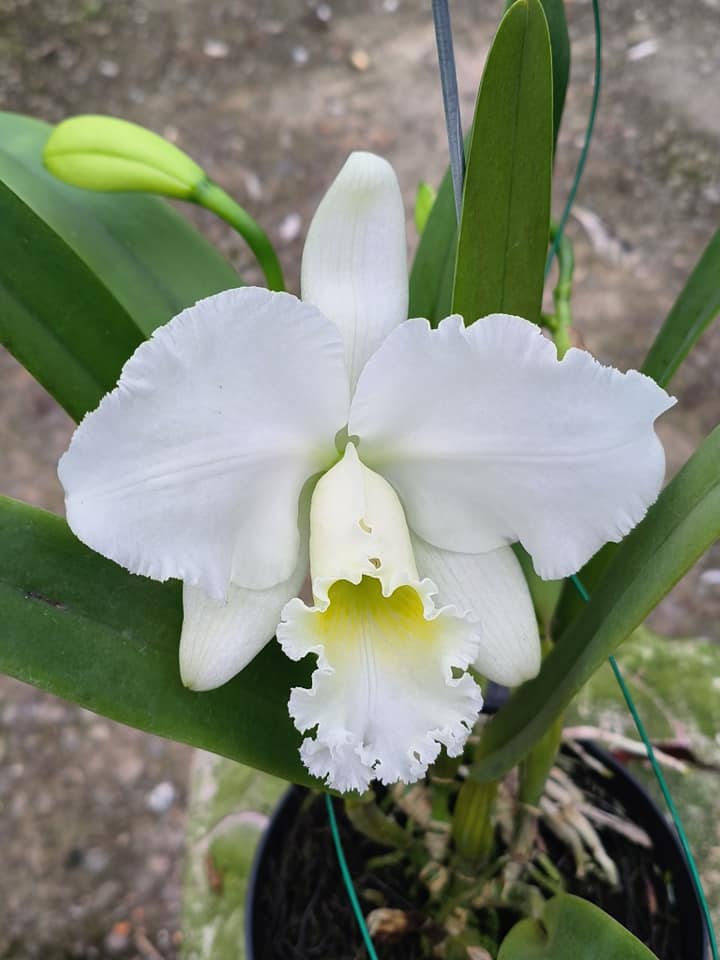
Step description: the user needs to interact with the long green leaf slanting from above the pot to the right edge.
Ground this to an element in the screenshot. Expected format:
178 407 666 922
471 427 720 780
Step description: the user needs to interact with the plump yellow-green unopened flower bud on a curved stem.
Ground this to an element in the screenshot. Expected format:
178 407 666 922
43 115 207 200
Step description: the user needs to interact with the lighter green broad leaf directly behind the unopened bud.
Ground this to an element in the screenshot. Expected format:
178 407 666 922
0 113 241 338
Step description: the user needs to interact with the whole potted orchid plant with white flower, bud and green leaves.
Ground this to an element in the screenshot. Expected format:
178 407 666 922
0 0 720 960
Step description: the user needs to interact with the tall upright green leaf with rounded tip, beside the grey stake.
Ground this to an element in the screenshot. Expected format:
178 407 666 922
452 0 553 323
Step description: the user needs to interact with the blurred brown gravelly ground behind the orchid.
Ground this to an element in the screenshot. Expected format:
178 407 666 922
0 0 720 960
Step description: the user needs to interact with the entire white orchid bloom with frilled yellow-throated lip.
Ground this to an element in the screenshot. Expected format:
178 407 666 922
59 153 674 790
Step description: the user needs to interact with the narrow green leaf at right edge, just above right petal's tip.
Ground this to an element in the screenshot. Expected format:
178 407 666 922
642 230 720 387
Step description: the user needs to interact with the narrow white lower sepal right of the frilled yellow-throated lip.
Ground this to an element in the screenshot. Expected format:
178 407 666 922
412 536 540 687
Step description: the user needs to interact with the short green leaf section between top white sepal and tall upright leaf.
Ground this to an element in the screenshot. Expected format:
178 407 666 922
409 168 457 326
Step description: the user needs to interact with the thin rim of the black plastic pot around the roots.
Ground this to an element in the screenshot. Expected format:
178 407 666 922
245 743 709 960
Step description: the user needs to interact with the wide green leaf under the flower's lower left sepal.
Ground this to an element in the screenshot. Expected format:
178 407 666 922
0 497 310 783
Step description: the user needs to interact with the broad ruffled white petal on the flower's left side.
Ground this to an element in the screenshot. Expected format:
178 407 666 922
59 288 348 599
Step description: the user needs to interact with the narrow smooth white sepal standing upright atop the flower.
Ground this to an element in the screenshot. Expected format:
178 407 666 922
301 153 408 384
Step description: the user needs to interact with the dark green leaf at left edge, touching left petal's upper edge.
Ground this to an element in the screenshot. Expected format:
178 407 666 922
0 183 144 420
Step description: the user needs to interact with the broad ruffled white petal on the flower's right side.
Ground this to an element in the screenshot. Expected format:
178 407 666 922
349 314 674 579
